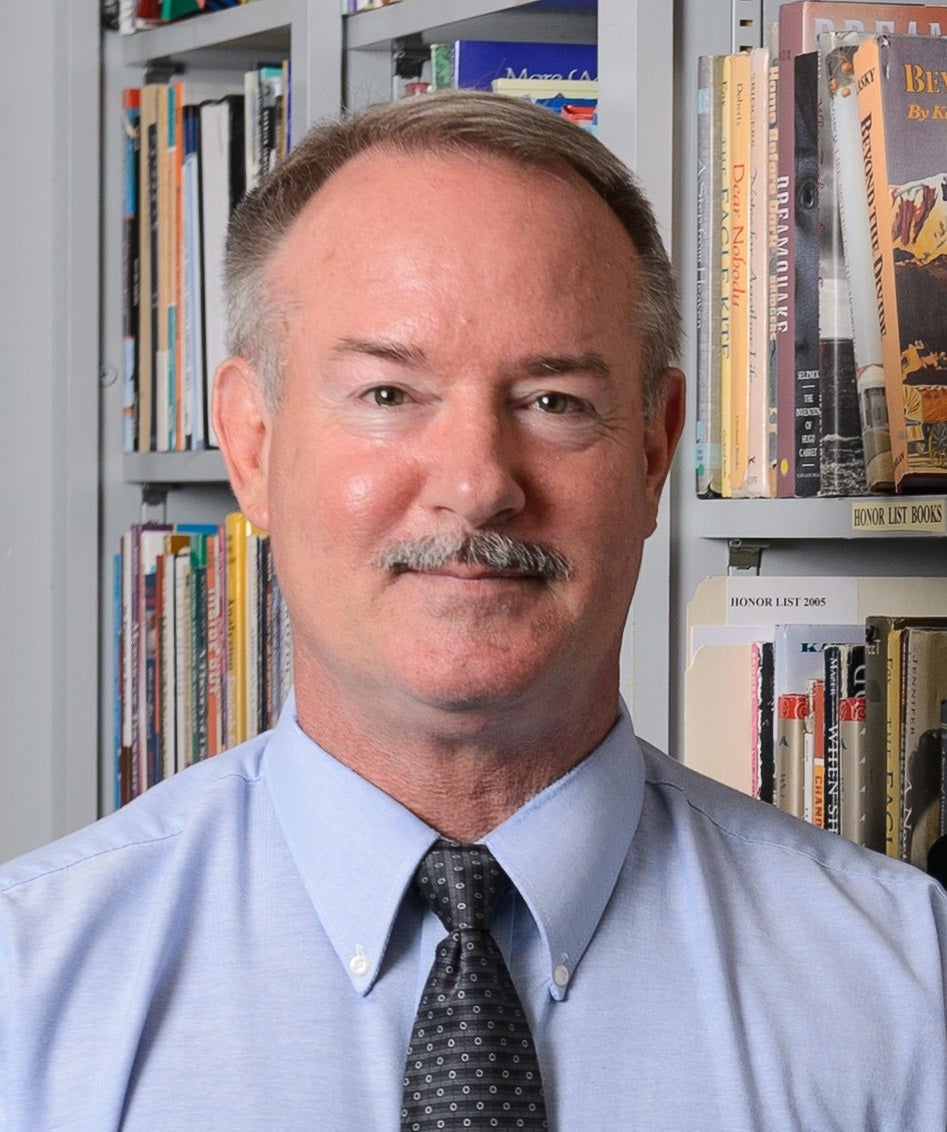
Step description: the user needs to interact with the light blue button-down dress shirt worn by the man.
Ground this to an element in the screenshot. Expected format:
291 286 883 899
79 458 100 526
0 700 947 1132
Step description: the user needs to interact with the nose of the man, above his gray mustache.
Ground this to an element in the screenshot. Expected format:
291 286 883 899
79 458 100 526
424 401 526 530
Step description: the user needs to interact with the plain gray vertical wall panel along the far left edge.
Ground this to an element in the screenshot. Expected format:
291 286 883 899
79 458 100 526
0 0 98 859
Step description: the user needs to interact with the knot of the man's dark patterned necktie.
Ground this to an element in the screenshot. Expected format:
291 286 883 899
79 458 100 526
414 841 509 932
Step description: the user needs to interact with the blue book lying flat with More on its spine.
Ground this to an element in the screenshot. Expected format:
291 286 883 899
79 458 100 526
454 40 599 91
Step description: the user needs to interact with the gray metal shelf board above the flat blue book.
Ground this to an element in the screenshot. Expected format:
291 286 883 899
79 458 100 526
345 0 597 49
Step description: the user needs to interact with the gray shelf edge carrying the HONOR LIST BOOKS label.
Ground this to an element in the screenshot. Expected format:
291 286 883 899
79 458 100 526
692 496 947 541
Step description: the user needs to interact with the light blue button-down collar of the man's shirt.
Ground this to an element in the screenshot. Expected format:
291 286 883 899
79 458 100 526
264 696 644 998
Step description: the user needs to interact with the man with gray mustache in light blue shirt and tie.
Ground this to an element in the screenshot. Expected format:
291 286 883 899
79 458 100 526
0 94 947 1132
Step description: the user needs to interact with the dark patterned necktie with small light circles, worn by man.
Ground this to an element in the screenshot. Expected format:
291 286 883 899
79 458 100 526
402 841 548 1132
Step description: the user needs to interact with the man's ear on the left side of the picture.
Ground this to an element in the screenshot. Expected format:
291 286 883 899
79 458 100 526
212 358 272 531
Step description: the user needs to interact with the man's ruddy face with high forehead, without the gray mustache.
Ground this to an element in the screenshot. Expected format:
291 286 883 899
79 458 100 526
218 143 679 733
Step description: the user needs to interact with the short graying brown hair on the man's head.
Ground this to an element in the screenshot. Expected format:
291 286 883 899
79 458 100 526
224 91 681 417
